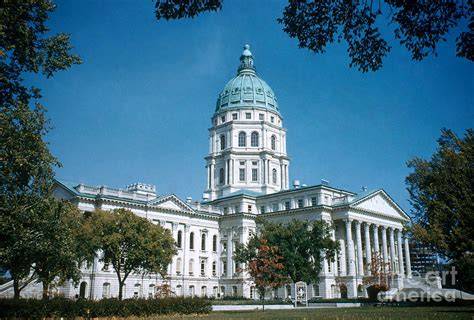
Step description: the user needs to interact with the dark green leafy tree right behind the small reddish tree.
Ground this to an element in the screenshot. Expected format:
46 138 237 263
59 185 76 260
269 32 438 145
252 219 339 304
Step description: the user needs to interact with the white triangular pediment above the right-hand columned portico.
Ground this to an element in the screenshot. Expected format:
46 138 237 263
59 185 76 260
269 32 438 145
351 190 410 220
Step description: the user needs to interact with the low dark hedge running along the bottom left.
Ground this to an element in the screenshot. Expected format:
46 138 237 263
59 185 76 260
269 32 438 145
0 297 212 319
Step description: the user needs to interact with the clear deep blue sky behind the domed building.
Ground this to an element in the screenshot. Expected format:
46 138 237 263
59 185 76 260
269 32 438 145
32 0 474 215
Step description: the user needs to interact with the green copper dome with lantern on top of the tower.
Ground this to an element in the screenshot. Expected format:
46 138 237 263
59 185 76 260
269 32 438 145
216 45 279 113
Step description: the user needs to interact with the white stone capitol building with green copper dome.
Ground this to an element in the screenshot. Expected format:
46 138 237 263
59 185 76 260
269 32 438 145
1 46 411 299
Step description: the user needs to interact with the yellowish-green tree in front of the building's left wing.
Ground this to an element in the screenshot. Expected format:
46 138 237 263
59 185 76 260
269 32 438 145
85 209 177 300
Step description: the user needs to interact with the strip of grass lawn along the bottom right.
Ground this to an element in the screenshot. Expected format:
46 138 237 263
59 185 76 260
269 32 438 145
159 306 474 320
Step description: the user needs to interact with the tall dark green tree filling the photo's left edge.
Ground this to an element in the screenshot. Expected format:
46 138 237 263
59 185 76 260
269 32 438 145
0 0 80 298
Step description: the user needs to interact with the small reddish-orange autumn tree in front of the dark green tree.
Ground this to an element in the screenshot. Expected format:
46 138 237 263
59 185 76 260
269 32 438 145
234 239 288 310
